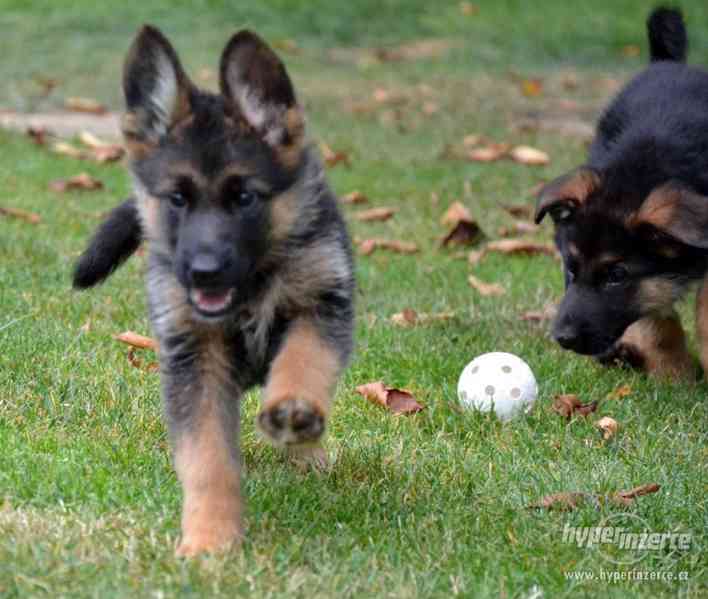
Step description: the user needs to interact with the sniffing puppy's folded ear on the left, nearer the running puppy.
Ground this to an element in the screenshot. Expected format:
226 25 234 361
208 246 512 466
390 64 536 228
534 166 601 224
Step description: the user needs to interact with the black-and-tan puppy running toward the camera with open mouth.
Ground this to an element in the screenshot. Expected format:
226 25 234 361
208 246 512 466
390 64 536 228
74 26 354 556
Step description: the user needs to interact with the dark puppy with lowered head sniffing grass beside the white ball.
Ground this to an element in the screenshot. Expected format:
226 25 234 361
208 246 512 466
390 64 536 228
535 8 708 374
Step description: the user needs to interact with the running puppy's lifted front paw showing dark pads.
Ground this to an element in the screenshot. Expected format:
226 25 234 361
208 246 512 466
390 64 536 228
258 397 325 445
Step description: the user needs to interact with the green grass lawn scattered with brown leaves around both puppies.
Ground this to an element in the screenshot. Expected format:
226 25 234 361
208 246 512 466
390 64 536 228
0 0 708 599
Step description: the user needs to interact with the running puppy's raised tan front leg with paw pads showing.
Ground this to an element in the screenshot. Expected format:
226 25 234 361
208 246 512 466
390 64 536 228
258 318 342 468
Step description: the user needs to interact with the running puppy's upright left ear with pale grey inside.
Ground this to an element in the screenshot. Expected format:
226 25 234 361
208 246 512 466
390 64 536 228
123 25 192 147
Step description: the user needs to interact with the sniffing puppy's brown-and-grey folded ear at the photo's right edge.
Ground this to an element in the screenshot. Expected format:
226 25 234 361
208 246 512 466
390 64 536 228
630 181 708 249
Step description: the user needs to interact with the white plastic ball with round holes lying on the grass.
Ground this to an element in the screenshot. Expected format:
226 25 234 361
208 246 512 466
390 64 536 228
457 352 538 420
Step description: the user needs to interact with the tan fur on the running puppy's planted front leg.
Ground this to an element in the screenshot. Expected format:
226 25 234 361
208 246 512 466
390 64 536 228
175 333 242 556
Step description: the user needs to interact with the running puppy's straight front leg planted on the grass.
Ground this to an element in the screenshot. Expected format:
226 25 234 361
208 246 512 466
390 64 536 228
160 337 242 557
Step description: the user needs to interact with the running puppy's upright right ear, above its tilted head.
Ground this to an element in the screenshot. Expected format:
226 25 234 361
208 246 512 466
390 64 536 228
219 31 304 154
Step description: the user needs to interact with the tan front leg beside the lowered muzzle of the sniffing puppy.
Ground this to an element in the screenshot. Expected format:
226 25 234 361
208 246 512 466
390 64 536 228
601 313 695 378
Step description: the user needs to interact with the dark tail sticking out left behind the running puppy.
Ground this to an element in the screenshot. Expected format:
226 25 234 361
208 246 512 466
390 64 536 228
73 198 142 289
